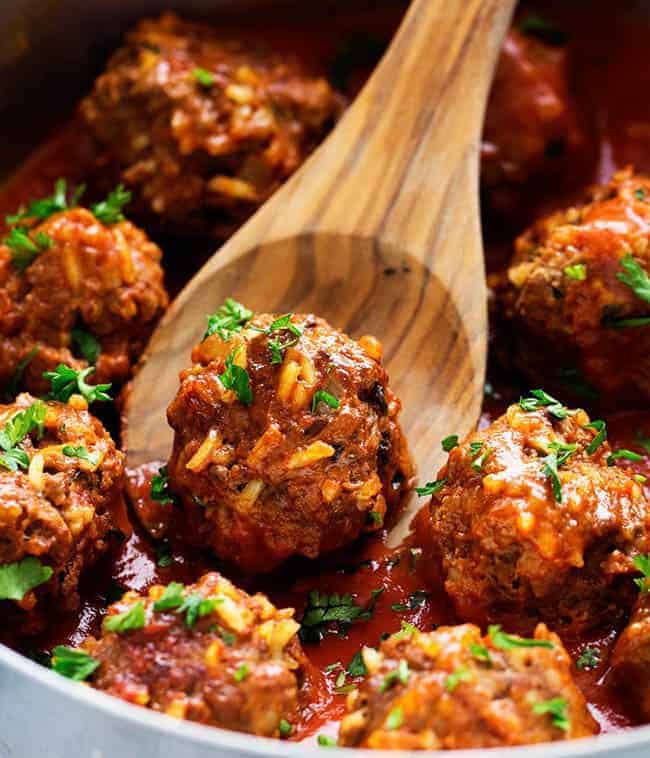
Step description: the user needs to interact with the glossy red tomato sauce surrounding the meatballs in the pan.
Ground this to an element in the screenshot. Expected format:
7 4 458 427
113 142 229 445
0 0 650 739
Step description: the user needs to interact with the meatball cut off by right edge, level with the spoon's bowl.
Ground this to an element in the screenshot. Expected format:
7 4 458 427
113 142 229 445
501 170 650 406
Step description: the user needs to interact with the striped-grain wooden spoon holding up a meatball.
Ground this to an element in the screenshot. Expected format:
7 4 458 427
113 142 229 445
123 0 515 528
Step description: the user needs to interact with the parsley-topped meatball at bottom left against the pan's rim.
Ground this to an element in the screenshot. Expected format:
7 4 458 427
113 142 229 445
83 573 304 737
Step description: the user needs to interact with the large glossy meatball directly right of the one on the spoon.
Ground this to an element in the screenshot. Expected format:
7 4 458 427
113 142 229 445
430 400 650 632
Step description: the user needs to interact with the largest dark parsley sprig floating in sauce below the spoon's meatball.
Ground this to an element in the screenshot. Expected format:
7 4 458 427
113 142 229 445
300 588 384 643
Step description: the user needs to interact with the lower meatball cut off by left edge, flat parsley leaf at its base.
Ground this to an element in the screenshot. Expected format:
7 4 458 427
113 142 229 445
0 393 125 612
